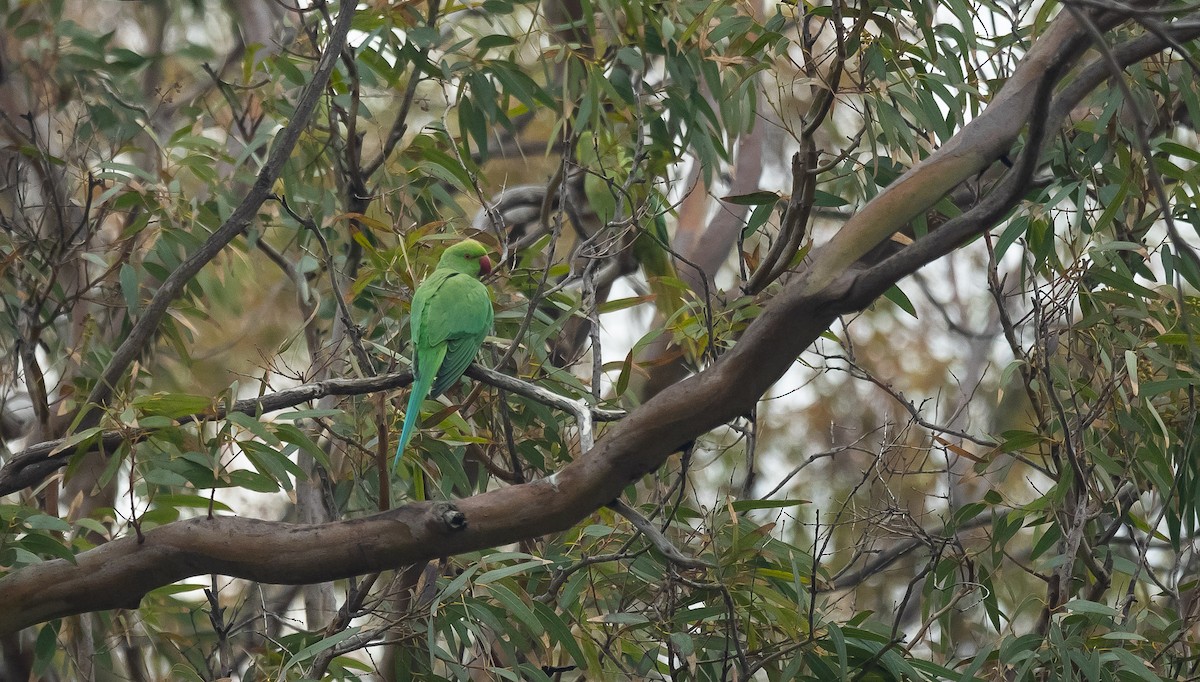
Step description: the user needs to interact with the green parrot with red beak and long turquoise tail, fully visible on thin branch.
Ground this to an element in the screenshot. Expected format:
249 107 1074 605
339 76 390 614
392 239 493 469
